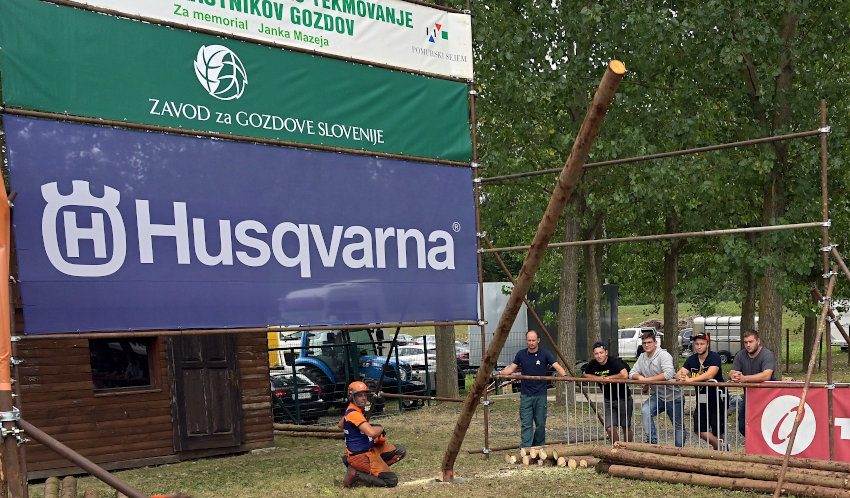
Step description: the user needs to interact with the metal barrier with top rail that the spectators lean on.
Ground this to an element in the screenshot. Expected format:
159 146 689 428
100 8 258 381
490 375 850 451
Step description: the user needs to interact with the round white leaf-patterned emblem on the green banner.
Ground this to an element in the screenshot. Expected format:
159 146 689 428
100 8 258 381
195 45 248 100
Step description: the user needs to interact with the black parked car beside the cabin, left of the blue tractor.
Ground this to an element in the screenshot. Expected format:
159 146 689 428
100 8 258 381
270 373 327 424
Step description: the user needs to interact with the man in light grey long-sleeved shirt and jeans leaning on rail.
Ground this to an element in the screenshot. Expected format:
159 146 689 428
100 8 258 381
629 331 685 447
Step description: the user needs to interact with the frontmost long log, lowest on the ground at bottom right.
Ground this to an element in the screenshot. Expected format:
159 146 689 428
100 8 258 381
596 462 847 497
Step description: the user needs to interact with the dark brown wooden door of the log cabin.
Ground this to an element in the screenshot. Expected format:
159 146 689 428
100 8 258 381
168 334 242 451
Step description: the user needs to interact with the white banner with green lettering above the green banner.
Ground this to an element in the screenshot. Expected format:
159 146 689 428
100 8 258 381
70 0 472 79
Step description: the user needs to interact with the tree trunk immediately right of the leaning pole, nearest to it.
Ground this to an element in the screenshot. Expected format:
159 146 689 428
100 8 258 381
555 200 579 406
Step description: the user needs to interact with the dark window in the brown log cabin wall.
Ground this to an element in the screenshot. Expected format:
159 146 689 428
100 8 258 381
89 338 154 392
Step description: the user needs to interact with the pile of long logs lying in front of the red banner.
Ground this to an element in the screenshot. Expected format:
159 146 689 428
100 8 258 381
591 443 850 497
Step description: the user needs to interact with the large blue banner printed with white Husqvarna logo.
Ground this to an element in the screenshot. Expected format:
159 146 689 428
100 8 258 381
3 115 477 334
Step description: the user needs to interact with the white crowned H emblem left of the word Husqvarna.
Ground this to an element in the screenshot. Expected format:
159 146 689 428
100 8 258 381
41 180 127 277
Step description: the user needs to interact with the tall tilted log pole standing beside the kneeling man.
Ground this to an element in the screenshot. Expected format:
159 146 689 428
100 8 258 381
440 61 626 482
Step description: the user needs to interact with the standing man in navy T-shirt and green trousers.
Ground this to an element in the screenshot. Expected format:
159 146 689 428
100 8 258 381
500 330 567 448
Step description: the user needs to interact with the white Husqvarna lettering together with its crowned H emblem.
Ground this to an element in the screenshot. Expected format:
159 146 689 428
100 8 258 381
41 180 461 278
